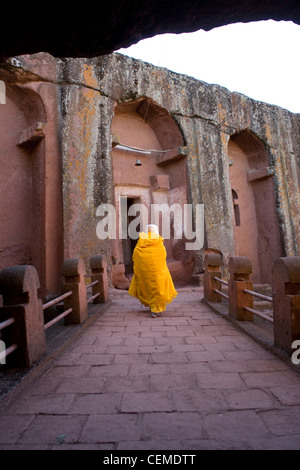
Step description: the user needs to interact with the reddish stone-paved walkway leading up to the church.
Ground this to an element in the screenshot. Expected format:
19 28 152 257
0 287 300 451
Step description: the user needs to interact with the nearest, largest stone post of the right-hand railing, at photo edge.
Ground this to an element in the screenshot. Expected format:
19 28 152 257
272 256 300 353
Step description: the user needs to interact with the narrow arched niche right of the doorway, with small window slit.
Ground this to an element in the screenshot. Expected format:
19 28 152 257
228 130 282 284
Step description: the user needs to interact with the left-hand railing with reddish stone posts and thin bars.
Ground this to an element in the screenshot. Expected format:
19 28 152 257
0 255 109 367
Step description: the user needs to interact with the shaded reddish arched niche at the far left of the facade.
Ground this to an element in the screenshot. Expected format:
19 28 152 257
0 83 46 292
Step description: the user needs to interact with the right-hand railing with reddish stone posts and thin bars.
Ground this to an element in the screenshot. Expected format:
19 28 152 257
204 253 300 353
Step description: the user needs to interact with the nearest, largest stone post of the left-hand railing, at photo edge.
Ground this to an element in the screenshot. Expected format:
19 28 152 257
0 265 46 367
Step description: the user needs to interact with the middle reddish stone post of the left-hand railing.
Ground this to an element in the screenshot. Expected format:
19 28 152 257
63 258 88 325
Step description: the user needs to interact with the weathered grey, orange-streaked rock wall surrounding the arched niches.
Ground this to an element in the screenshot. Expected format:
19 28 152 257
0 53 300 290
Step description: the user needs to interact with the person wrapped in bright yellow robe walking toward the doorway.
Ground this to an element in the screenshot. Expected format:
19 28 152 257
128 224 177 317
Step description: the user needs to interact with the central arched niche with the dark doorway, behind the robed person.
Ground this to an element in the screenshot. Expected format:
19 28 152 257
111 98 192 284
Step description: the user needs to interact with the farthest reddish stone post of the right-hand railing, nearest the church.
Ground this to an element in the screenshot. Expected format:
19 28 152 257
204 253 222 302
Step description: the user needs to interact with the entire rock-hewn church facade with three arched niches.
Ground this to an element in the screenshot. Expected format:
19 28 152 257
0 53 300 297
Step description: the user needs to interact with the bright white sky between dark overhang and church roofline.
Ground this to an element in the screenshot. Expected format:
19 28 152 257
116 20 300 113
